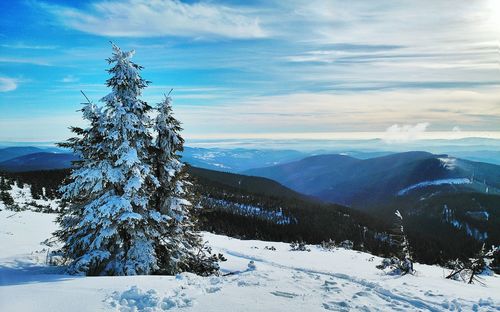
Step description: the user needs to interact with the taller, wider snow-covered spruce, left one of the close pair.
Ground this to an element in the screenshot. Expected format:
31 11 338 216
55 45 163 275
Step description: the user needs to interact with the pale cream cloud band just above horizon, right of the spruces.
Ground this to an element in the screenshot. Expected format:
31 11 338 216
174 87 500 136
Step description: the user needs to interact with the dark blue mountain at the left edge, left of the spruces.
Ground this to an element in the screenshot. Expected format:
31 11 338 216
0 152 76 172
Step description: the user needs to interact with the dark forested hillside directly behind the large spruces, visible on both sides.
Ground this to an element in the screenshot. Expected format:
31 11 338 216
0 167 390 254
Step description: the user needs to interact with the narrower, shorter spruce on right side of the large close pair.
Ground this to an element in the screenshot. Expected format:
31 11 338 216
154 96 223 275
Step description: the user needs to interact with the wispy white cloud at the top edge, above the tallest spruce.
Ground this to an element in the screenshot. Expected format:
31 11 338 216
41 0 266 38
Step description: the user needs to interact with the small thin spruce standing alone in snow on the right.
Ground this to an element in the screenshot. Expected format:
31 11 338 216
377 210 414 275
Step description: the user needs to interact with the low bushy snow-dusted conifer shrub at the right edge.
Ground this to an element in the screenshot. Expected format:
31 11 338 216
446 244 500 284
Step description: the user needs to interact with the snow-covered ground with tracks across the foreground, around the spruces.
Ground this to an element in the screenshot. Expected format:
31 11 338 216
0 210 500 312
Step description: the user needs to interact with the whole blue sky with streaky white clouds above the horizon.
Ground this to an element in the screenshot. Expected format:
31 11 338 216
0 0 500 142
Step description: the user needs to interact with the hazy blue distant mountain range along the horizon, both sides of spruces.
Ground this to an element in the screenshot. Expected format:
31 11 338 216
0 143 500 173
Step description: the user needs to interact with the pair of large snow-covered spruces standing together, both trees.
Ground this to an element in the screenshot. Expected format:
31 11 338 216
55 45 218 275
